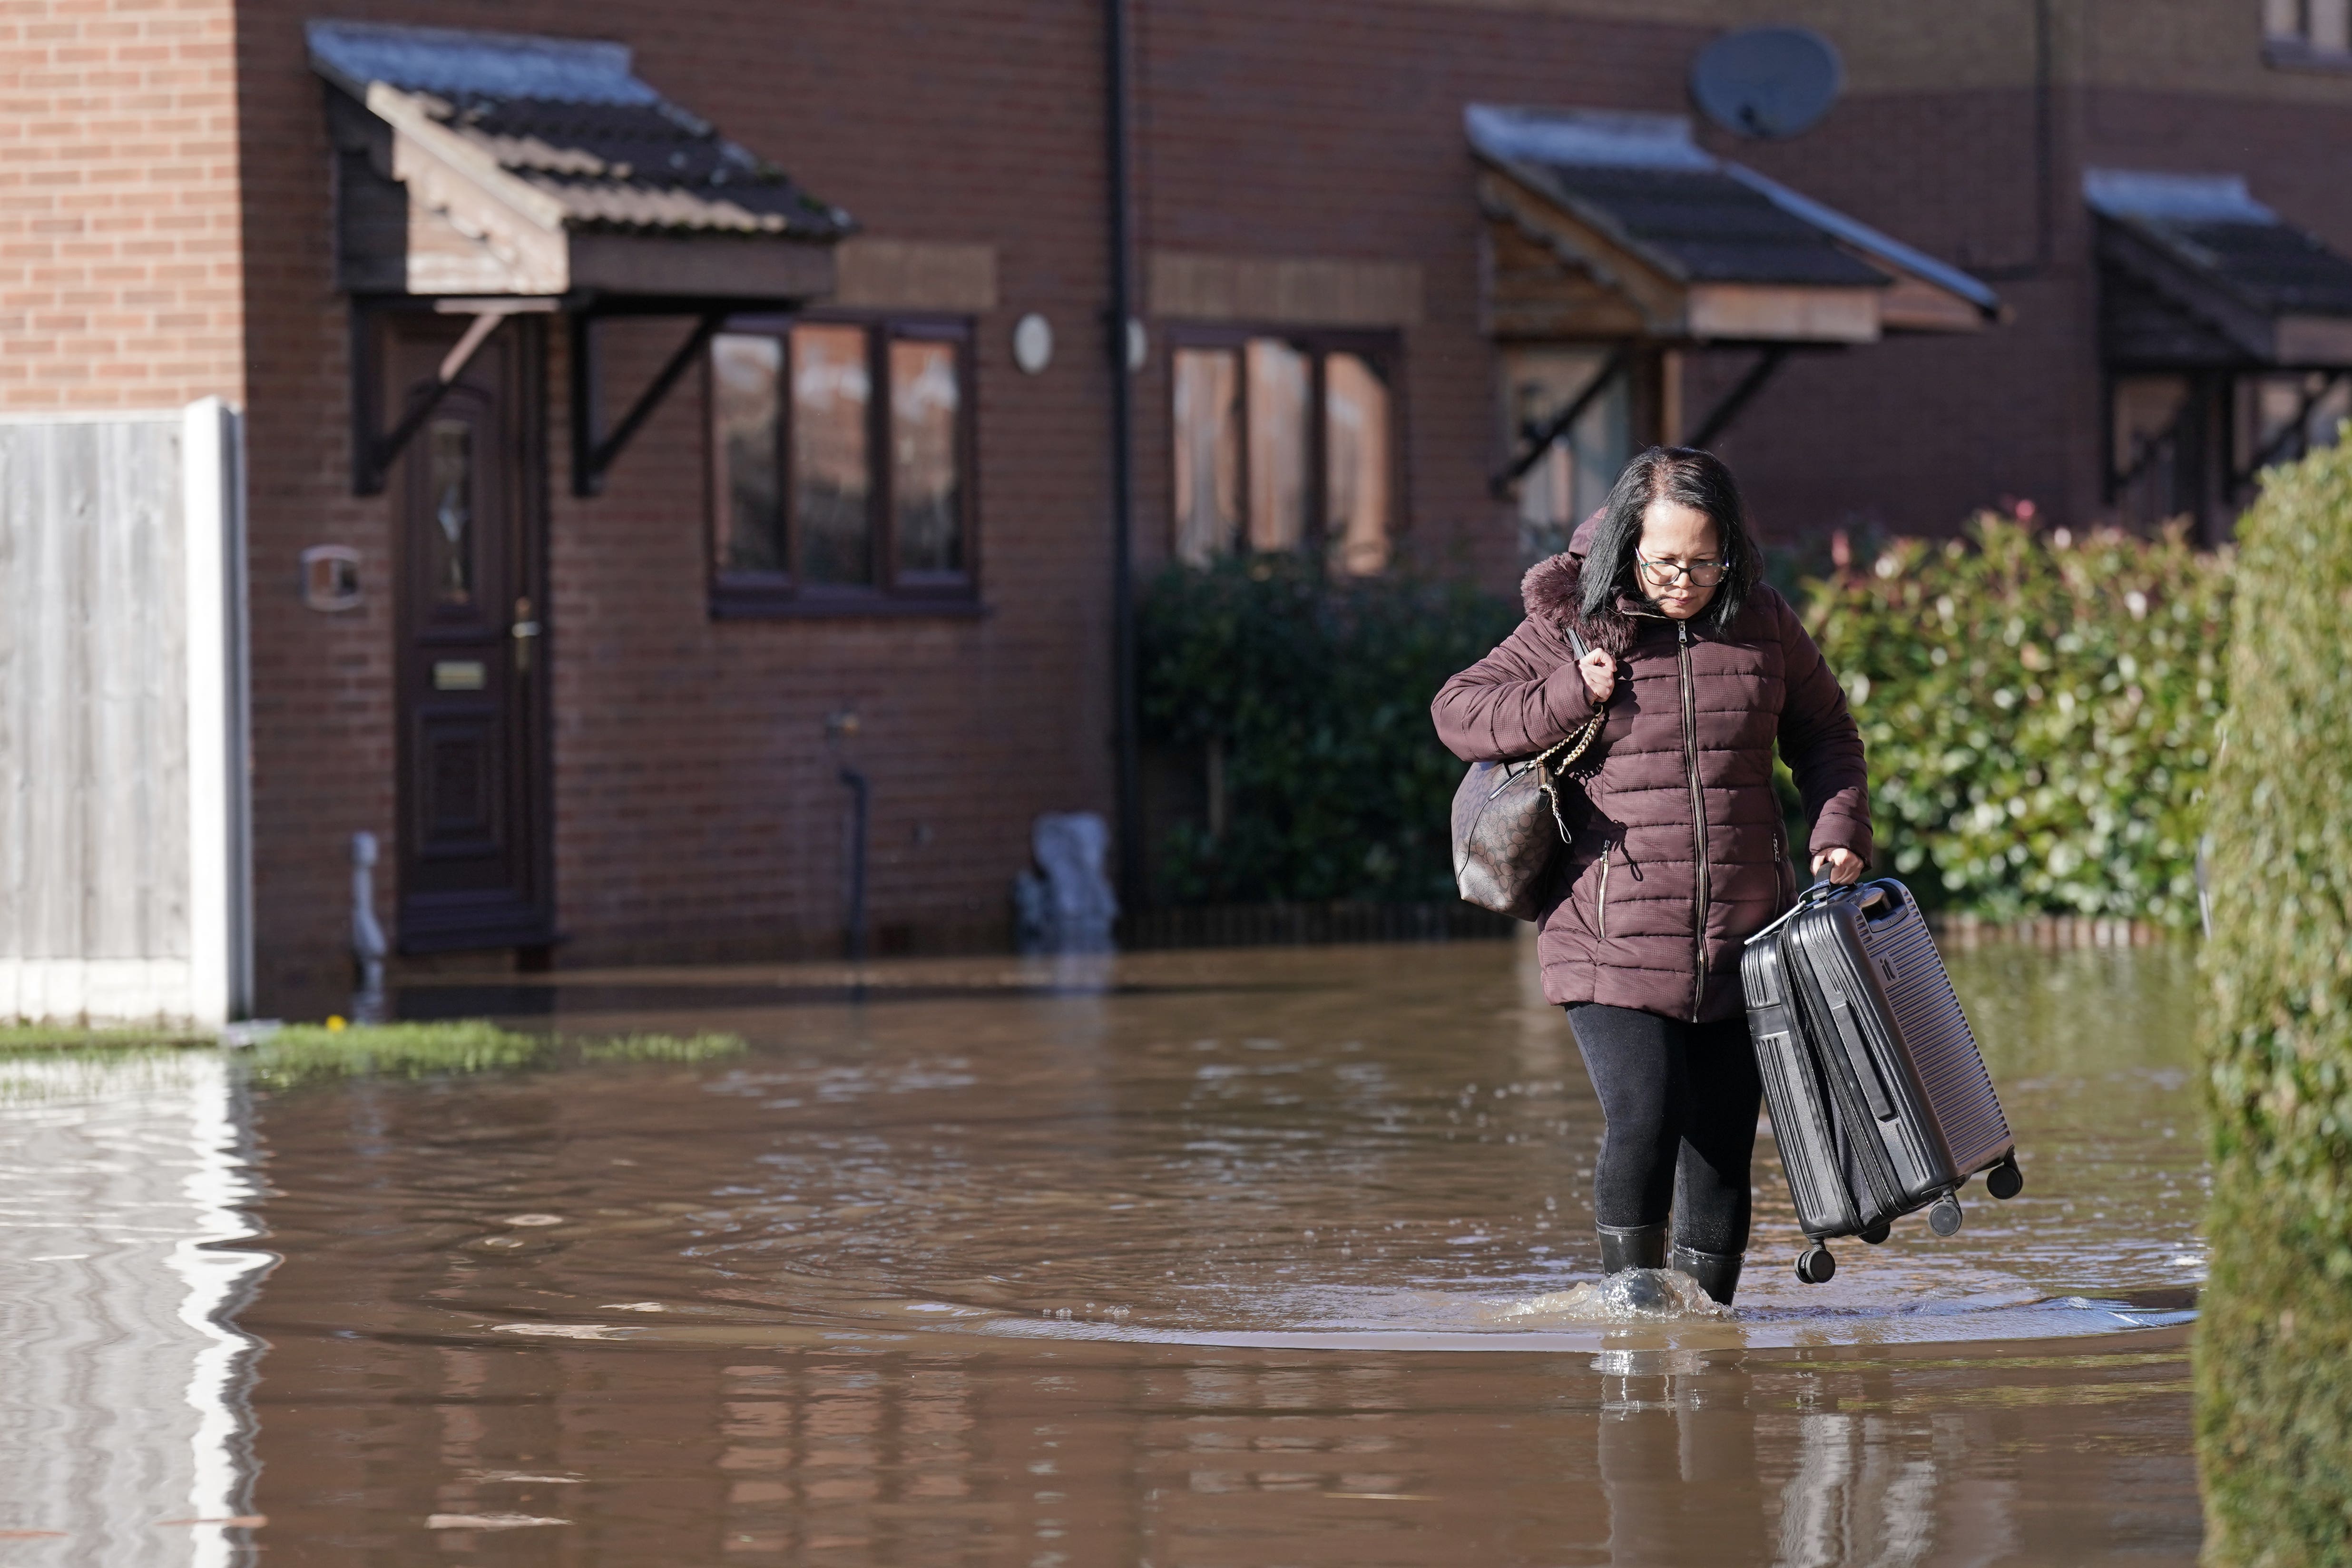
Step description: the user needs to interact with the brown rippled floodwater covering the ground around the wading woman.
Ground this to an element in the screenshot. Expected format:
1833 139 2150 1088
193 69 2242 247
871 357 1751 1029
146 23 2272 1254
0 943 2204 1568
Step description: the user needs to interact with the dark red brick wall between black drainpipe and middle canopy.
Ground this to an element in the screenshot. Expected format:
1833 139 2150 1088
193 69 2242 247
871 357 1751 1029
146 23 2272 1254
1136 0 1707 585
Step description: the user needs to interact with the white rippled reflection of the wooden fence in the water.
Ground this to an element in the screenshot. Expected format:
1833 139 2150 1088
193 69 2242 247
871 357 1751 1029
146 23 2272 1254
0 1051 268 1568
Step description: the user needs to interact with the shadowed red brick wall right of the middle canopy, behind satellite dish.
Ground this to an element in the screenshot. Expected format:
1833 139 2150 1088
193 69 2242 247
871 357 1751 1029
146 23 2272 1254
1691 89 2352 536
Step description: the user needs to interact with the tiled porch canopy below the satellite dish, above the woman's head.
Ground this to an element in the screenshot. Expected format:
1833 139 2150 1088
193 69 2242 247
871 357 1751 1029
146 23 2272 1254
1463 103 2001 484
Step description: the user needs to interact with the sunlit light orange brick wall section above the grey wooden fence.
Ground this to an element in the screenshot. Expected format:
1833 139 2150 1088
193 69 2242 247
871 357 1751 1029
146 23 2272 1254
0 0 245 414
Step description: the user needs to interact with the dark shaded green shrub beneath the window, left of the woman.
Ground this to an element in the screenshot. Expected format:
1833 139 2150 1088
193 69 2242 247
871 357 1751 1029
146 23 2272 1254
1138 555 1519 903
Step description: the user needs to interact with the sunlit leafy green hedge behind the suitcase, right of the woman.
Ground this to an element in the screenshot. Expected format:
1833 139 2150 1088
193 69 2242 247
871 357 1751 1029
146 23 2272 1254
1806 515 2230 926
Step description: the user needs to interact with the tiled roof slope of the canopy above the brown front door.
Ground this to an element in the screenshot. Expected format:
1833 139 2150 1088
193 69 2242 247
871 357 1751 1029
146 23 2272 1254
308 21 852 240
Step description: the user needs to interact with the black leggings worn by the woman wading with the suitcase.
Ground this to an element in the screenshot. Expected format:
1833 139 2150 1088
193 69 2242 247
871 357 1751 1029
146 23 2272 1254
1569 1001 1764 1253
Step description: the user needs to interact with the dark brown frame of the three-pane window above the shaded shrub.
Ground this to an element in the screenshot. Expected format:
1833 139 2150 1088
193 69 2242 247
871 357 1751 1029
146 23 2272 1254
1159 322 1413 576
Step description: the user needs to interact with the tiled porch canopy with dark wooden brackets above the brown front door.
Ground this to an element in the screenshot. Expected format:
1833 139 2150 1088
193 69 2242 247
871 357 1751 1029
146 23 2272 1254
306 21 854 494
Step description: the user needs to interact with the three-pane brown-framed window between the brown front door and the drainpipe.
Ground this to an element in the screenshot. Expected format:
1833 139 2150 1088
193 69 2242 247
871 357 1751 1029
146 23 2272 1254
710 320 974 614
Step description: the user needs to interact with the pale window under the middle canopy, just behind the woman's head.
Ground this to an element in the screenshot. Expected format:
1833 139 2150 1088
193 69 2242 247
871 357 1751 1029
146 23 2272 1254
1503 348 1632 567
